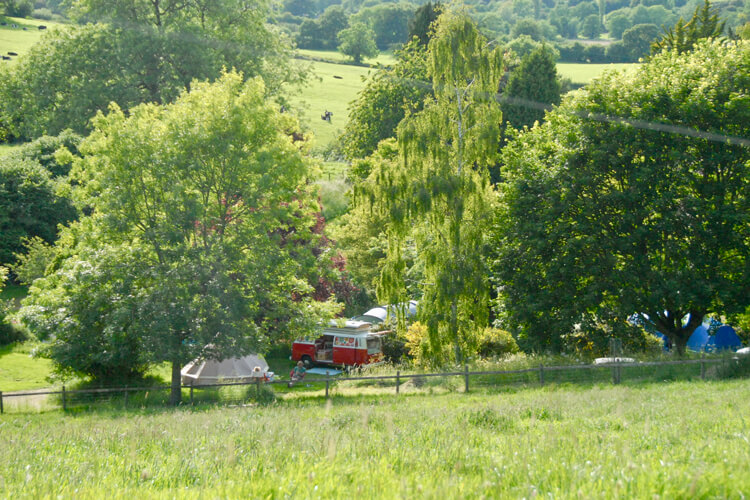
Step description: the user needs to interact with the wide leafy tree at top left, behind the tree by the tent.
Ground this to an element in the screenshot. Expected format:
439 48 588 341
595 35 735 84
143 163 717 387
0 0 299 139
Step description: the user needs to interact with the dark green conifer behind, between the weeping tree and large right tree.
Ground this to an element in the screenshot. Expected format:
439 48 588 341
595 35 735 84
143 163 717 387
502 45 562 128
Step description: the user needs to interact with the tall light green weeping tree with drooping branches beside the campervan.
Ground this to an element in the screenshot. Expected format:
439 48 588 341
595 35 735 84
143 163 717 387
362 12 502 363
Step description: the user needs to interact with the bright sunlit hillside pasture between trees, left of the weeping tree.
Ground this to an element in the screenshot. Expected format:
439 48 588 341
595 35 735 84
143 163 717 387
290 61 375 147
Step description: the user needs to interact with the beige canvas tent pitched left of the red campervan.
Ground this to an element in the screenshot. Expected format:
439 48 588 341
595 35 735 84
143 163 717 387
181 354 273 385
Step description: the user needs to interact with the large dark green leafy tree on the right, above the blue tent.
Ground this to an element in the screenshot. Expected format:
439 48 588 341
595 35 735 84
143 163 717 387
495 42 750 353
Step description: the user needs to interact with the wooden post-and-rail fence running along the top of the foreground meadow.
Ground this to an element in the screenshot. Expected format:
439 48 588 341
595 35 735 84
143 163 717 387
0 358 727 414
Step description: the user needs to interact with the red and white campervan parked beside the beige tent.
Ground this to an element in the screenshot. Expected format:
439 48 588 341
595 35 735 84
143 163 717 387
292 321 387 366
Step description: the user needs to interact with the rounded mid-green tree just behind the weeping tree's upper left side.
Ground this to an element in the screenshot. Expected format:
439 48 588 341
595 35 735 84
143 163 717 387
341 42 431 159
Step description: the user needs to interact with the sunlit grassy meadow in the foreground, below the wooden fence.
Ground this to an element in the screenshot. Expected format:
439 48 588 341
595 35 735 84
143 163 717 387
0 381 750 499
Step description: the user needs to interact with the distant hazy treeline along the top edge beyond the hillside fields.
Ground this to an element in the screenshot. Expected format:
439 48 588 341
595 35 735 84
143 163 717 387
276 0 750 63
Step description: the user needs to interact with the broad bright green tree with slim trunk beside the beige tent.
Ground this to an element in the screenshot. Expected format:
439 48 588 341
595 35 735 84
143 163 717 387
24 73 338 402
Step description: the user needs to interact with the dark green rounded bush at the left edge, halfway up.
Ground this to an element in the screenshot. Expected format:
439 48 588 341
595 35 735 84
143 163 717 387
0 157 77 265
